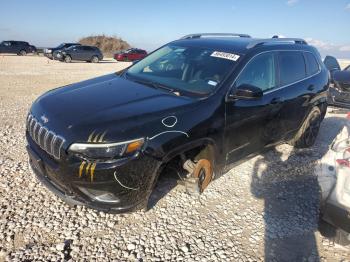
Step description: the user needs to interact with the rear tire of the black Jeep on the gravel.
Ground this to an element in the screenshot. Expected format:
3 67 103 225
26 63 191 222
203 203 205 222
292 107 322 148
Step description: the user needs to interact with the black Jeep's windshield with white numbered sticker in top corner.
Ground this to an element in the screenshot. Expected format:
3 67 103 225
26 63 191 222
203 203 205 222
126 45 239 95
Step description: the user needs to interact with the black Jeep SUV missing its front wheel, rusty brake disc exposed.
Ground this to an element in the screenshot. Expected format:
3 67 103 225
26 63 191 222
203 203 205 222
26 34 329 212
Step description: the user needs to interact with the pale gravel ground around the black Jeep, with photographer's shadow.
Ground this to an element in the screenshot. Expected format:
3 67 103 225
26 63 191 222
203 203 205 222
0 56 350 261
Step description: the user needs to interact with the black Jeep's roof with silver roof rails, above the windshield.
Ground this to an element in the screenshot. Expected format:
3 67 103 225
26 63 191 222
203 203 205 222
172 36 308 55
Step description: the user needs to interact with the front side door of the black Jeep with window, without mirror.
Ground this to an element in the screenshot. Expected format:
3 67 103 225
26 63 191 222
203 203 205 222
224 52 283 165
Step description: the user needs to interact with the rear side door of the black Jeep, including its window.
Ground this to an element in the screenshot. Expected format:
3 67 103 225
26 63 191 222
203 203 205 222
278 50 319 140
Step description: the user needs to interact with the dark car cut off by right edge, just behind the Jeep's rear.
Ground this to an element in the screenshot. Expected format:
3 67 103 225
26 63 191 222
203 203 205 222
324 56 350 108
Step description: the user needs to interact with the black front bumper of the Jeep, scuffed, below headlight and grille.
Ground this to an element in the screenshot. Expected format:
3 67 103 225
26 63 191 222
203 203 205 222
27 136 160 213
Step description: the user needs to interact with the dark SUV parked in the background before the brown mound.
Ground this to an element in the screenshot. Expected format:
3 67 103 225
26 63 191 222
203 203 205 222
54 45 103 63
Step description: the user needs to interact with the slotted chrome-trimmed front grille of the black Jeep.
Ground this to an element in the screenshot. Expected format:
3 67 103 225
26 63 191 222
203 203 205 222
27 115 65 159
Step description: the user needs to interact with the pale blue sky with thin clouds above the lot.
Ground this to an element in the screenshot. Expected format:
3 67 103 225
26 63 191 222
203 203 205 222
0 0 350 59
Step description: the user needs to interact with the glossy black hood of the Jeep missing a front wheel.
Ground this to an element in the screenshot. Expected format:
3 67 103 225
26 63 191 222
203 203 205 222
31 74 194 140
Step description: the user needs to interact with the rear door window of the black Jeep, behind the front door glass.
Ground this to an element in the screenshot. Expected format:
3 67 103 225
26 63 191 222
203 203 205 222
279 51 306 86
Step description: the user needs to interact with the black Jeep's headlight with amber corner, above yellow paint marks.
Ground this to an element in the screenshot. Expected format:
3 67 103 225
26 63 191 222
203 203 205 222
68 138 145 160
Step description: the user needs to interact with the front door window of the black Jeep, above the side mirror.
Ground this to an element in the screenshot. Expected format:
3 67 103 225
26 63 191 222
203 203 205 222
235 52 276 92
